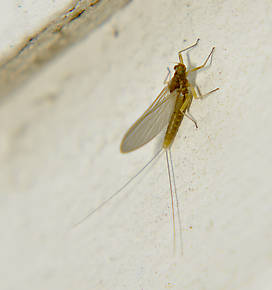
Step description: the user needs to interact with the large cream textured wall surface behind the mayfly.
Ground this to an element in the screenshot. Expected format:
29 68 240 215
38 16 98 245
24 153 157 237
0 0 272 290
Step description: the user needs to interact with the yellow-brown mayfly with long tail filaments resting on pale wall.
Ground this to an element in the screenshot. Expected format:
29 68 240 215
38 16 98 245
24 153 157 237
76 39 218 249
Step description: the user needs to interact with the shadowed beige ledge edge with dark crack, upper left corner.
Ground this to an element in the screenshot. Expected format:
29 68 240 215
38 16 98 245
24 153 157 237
0 0 132 102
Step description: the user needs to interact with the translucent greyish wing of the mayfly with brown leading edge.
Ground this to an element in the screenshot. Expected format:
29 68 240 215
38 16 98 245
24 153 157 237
120 86 177 153
